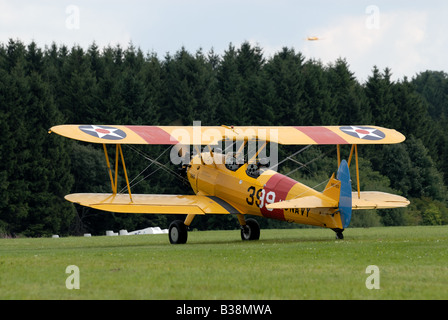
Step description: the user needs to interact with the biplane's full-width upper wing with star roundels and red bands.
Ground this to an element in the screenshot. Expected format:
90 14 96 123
50 125 405 145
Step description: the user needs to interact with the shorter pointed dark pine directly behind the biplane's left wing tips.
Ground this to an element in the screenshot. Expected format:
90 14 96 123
23 72 74 236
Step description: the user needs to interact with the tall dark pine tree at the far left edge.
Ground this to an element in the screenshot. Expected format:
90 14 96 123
0 40 30 234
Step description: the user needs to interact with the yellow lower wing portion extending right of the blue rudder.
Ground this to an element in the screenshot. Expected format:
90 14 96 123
352 191 410 210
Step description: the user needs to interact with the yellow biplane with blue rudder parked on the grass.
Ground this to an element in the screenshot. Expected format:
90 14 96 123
50 125 409 244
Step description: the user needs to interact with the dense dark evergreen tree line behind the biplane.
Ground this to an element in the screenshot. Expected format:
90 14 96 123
0 40 448 236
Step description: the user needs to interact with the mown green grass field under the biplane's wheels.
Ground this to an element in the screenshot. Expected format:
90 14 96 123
0 226 448 300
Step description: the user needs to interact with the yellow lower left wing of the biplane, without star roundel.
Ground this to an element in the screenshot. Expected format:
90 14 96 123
65 193 239 215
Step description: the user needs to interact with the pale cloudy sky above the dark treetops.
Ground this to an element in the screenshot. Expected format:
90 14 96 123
0 0 448 82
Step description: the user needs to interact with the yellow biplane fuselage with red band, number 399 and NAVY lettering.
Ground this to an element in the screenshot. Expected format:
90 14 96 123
187 152 342 229
